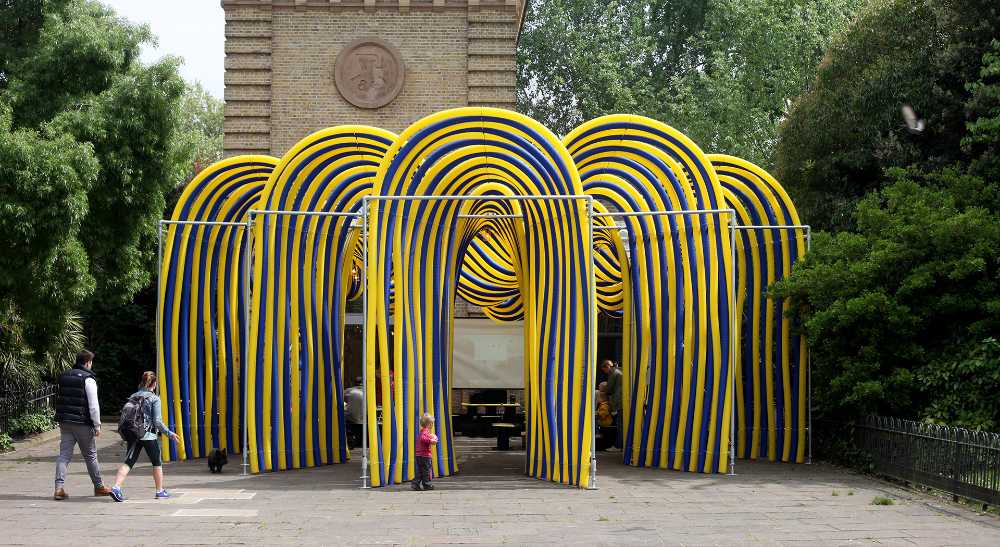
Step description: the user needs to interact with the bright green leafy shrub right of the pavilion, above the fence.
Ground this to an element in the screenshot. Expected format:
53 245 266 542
771 169 1000 424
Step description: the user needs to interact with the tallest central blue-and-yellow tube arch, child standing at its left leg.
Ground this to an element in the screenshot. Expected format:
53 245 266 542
364 108 596 486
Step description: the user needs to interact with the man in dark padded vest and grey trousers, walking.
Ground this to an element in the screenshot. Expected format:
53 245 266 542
53 350 111 500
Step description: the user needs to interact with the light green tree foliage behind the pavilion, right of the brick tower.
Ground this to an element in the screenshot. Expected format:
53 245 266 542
518 0 860 165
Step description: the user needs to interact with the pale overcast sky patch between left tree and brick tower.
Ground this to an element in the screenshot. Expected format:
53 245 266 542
101 0 225 99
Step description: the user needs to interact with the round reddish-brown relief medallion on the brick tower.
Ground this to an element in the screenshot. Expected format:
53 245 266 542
333 38 405 108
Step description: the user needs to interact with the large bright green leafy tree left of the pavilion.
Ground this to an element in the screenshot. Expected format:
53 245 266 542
0 0 190 388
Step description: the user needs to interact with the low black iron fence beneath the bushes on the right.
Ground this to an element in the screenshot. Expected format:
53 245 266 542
853 416 1000 505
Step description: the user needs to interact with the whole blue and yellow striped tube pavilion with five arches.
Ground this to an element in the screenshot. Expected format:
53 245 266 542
157 108 809 487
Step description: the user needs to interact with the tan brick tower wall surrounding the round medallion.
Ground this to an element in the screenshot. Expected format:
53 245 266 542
222 0 522 157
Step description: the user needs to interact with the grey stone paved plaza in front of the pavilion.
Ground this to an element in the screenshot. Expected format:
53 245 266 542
0 434 1000 546
